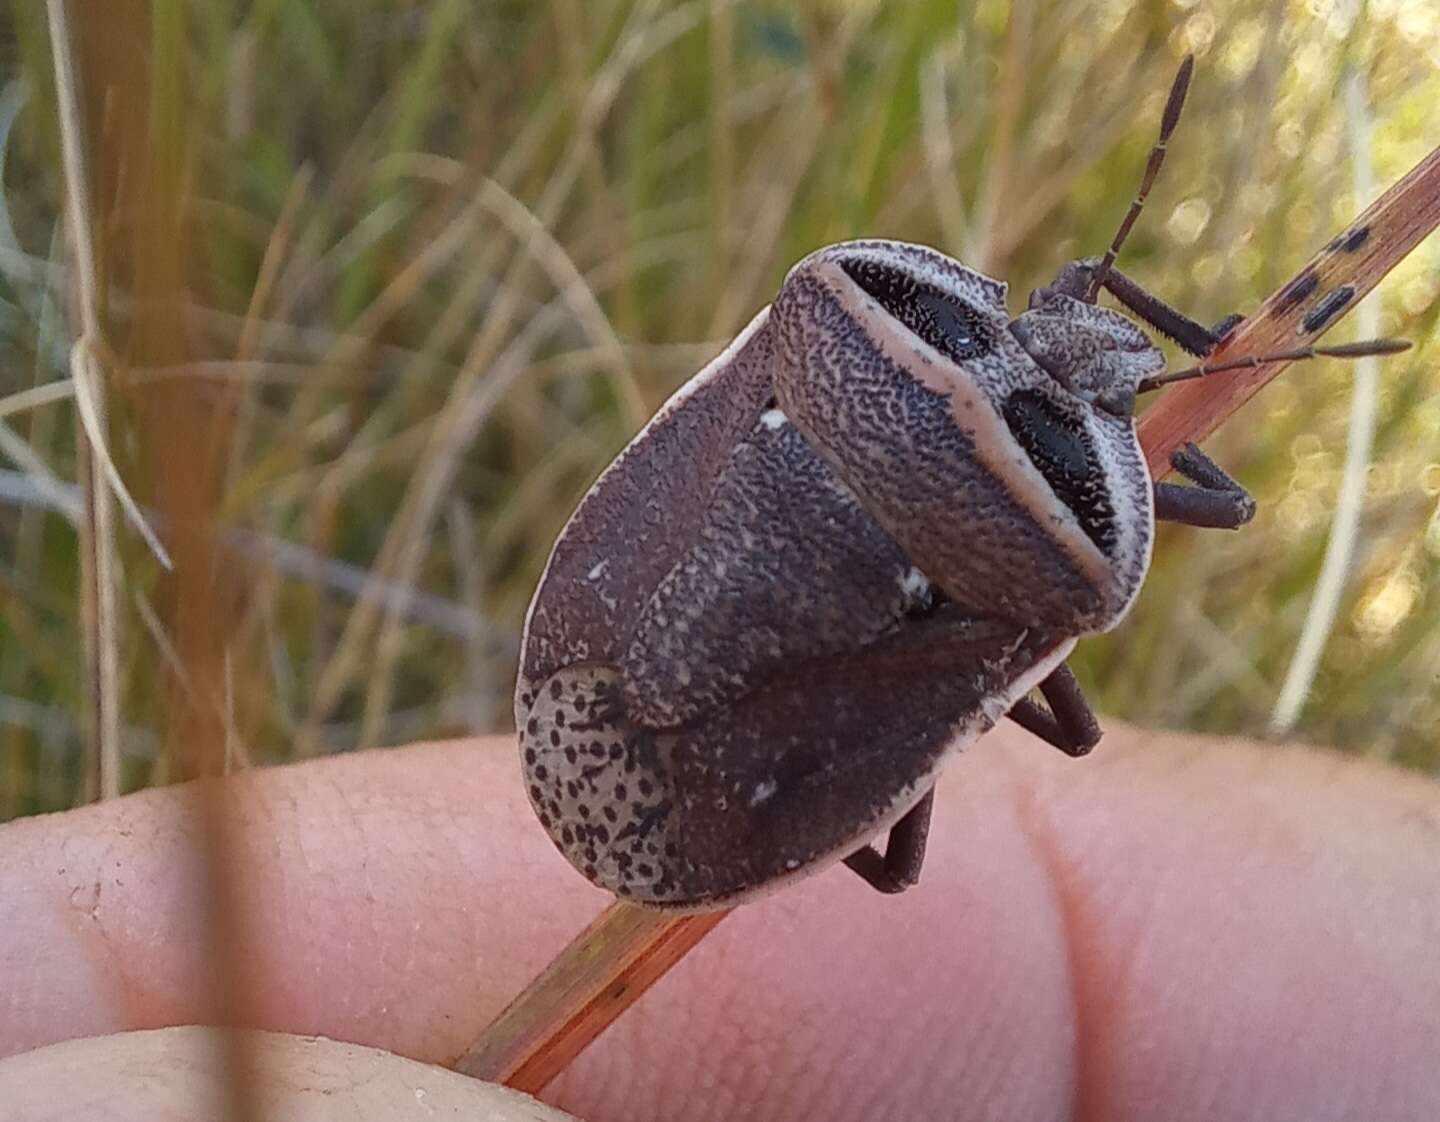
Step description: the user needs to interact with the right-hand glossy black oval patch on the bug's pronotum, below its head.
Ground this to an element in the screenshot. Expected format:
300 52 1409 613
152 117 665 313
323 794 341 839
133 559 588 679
1004 390 1116 552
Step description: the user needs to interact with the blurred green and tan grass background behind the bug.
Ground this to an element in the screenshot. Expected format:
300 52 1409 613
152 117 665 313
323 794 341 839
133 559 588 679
0 0 1440 820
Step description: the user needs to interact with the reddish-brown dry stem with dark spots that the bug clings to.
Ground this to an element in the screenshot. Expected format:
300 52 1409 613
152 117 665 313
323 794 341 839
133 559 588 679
455 140 1440 1092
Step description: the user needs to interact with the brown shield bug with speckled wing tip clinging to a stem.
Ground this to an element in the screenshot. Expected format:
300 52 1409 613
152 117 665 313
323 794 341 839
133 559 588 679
516 59 1405 910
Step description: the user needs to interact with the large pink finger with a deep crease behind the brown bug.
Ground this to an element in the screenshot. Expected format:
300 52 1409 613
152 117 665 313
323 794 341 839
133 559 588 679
0 726 1440 1122
